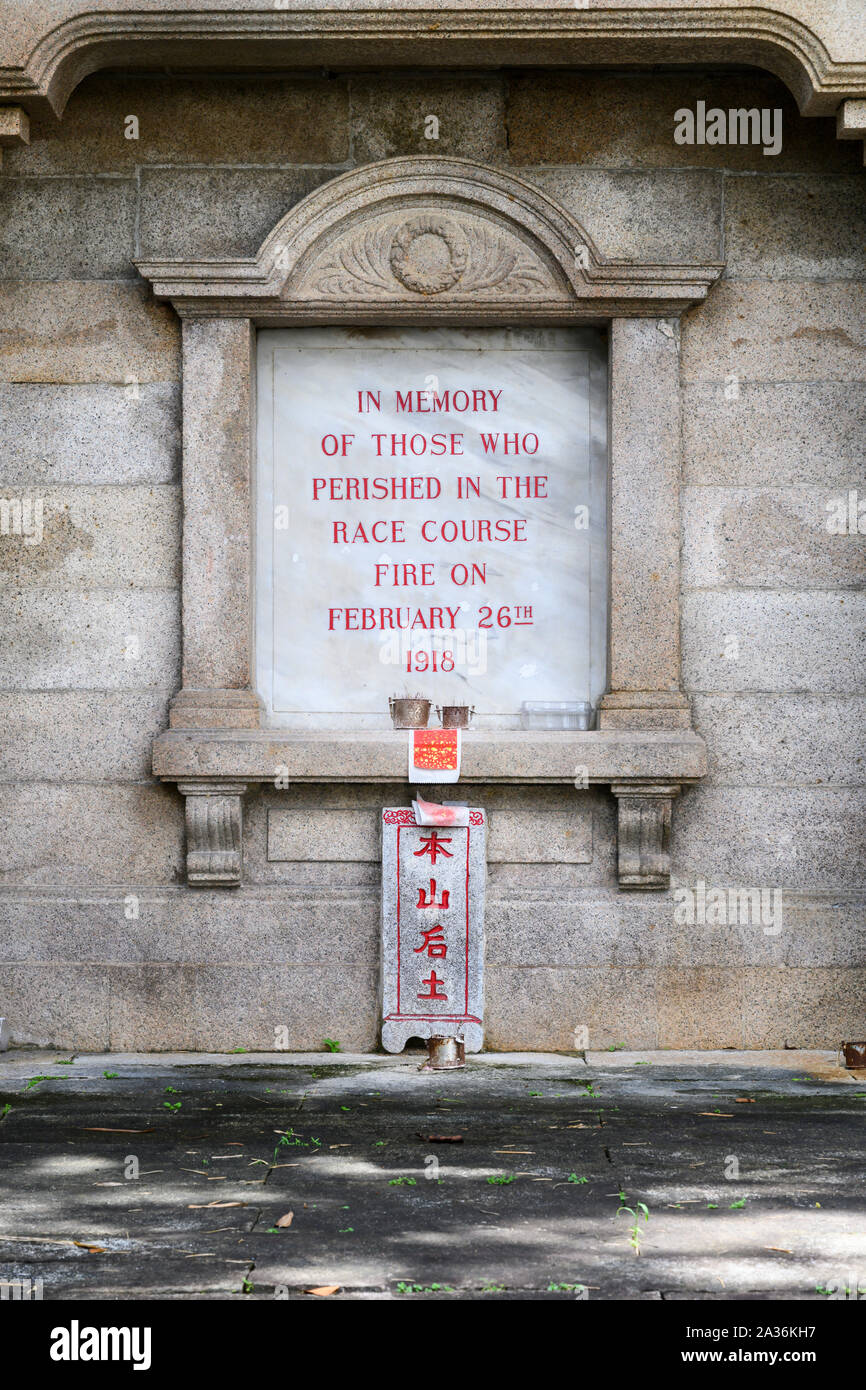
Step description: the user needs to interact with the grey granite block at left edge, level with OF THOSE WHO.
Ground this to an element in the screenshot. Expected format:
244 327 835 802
0 382 181 488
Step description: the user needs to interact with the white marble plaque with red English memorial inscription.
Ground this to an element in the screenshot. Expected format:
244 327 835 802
256 328 607 727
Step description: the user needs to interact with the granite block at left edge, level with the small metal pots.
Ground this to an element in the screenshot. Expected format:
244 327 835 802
0 689 174 783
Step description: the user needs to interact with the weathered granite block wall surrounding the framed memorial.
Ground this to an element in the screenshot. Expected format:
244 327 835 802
0 70 866 1049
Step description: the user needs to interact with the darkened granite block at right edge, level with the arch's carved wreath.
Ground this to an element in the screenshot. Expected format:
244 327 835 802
724 172 866 279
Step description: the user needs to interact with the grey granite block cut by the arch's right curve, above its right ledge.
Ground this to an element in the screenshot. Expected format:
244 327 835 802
528 167 723 263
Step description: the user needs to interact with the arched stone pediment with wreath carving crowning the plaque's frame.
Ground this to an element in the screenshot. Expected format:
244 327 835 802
136 156 723 324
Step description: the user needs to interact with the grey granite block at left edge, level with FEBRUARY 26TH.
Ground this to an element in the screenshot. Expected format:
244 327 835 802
0 589 181 691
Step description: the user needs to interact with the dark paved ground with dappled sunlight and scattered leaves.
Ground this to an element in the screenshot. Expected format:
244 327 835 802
0 1051 866 1300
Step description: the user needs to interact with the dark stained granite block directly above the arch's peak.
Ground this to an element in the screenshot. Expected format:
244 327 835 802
350 75 506 164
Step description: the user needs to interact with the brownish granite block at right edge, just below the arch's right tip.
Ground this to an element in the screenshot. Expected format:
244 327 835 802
683 279 866 382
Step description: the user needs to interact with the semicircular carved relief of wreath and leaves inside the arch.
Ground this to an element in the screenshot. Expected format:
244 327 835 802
310 213 550 299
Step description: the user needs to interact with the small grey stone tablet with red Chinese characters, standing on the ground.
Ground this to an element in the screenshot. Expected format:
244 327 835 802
382 806 487 1052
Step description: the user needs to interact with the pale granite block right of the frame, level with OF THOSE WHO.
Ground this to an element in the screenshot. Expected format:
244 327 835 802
683 379 866 488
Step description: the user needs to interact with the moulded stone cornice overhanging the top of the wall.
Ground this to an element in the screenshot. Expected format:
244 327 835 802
0 0 866 115
